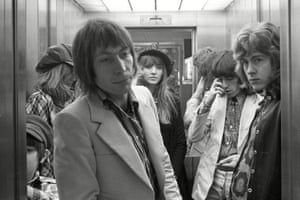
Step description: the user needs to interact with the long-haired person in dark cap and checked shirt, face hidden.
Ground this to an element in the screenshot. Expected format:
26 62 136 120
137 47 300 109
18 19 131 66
26 44 75 126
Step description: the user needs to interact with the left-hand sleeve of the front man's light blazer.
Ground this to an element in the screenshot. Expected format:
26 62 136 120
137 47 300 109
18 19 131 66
54 113 100 200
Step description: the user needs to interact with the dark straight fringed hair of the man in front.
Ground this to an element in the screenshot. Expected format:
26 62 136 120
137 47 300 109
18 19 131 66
72 18 137 93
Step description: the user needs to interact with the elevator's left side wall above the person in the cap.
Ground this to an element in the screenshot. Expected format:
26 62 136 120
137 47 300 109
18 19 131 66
26 0 82 96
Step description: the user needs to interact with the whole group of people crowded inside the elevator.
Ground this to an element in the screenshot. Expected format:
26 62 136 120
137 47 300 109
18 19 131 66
26 16 281 200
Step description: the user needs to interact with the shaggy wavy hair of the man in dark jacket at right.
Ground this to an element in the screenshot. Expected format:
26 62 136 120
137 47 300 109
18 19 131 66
233 22 280 98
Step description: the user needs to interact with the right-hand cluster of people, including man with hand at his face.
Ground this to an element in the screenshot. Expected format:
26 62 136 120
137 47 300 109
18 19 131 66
185 23 281 200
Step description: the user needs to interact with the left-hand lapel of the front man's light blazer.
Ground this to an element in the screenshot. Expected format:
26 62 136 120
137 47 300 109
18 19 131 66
88 95 152 188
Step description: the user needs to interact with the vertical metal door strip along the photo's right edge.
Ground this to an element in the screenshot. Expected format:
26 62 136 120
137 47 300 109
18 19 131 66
280 0 300 200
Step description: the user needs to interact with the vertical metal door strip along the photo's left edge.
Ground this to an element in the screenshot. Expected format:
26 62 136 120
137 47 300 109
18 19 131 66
0 0 16 199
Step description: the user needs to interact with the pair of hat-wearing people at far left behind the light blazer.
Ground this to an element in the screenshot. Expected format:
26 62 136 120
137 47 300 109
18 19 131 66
25 44 76 200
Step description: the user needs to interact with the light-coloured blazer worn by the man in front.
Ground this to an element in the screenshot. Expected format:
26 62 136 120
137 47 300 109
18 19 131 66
54 86 181 200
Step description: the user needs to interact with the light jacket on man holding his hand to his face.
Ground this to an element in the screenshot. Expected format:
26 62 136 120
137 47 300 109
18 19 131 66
189 94 261 200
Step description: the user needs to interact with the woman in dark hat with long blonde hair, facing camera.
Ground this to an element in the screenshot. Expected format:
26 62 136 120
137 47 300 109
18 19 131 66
137 49 187 199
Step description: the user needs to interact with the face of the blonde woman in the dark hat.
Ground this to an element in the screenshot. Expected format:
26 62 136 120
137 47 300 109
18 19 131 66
139 55 166 85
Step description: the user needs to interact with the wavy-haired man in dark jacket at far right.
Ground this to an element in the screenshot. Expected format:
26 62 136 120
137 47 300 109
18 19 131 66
231 23 281 200
